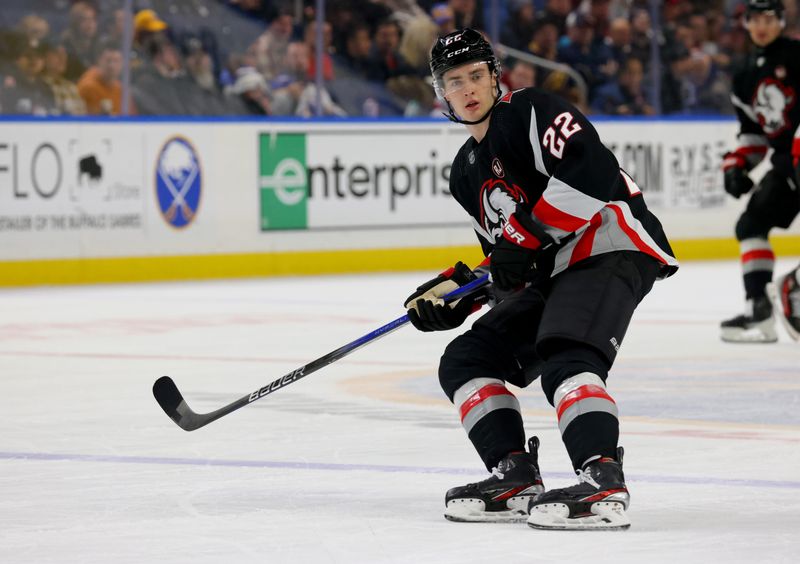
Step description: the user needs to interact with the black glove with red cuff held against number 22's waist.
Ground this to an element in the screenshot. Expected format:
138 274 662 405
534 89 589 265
490 210 555 291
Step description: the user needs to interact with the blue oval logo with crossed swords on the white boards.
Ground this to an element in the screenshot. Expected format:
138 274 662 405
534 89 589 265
156 136 203 229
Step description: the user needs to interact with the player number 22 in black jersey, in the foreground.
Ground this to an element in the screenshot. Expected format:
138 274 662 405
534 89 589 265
405 29 677 529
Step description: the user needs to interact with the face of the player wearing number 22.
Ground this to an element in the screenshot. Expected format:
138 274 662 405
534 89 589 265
442 62 495 121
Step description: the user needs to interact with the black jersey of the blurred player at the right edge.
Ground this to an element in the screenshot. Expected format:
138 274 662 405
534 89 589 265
731 37 800 176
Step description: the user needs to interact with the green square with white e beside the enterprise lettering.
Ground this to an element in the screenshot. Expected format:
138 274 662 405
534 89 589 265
259 133 308 231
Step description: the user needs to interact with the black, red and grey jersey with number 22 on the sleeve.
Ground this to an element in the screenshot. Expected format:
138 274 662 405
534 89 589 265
450 88 678 278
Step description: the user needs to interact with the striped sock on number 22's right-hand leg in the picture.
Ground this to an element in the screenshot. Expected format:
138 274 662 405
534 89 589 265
553 372 619 469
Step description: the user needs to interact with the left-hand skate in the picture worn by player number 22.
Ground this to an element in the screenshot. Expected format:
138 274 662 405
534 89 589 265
444 437 544 523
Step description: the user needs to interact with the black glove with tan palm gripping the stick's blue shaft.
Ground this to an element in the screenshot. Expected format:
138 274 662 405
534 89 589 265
405 262 485 331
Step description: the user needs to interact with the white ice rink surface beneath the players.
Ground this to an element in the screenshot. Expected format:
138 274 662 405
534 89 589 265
0 259 800 564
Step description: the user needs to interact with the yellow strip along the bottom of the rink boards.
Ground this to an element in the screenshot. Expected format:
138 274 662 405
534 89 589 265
0 236 800 286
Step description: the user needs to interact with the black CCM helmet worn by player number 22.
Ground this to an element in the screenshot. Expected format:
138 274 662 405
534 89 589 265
431 28 502 124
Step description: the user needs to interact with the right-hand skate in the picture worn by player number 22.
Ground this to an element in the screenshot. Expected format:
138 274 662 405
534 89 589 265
528 447 631 530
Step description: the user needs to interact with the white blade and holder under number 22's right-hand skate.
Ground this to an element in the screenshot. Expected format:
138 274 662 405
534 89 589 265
528 501 631 531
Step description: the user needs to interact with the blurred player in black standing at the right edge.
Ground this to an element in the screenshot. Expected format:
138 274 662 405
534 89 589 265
720 0 800 343
